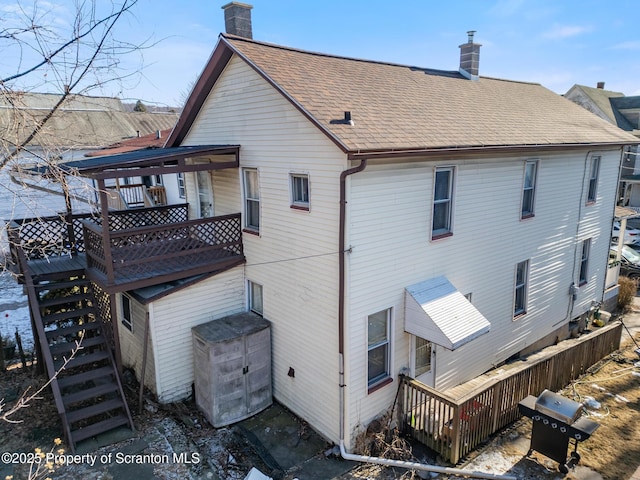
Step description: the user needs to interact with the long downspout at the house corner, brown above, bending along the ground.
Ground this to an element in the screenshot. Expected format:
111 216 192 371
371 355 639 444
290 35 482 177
338 158 517 480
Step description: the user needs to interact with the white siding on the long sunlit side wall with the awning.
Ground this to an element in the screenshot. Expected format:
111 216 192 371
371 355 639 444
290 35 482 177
345 151 619 432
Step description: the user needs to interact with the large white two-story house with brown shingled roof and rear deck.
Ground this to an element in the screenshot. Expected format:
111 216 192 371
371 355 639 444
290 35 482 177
8 4 636 454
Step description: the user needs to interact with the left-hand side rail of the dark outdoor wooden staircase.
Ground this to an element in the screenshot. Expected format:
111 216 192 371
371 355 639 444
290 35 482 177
16 246 75 445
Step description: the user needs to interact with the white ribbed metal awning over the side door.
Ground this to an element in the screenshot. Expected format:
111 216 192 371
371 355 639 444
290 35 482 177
404 277 491 350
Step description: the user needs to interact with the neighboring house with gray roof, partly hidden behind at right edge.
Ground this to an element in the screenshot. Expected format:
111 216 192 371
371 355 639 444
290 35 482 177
564 82 640 213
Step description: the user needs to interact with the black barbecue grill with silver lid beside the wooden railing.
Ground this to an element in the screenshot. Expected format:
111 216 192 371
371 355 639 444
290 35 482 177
518 390 600 474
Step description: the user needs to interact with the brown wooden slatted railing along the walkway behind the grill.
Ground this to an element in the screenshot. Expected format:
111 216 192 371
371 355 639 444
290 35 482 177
399 322 622 464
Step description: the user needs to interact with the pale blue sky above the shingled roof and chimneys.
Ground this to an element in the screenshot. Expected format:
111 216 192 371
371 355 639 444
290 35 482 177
0 0 640 106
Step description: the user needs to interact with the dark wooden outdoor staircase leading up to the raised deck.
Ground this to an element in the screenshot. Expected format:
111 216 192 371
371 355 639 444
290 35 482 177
22 262 133 451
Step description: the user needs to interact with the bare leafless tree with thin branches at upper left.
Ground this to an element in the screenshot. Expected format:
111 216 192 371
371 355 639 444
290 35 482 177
0 0 150 271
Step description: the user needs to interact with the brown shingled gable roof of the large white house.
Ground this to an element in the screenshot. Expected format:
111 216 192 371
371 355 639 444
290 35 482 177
167 34 634 152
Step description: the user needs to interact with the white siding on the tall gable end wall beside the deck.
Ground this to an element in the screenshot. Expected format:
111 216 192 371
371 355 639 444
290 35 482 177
183 57 348 441
